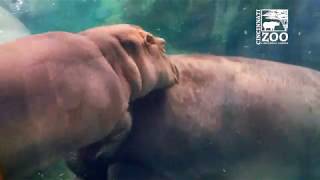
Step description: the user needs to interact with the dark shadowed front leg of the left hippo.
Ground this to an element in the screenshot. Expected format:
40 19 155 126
66 113 131 180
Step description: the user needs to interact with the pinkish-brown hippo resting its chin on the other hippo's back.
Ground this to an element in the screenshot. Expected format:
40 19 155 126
0 25 177 180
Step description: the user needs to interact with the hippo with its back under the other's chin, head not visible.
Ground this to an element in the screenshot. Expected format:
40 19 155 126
71 55 320 180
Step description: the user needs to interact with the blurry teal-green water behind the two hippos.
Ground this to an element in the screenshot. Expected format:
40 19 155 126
0 0 320 180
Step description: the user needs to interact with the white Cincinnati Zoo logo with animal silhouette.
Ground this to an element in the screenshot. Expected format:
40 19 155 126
256 9 289 45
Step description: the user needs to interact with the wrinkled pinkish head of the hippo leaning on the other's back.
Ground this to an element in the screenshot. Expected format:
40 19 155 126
81 24 178 99
